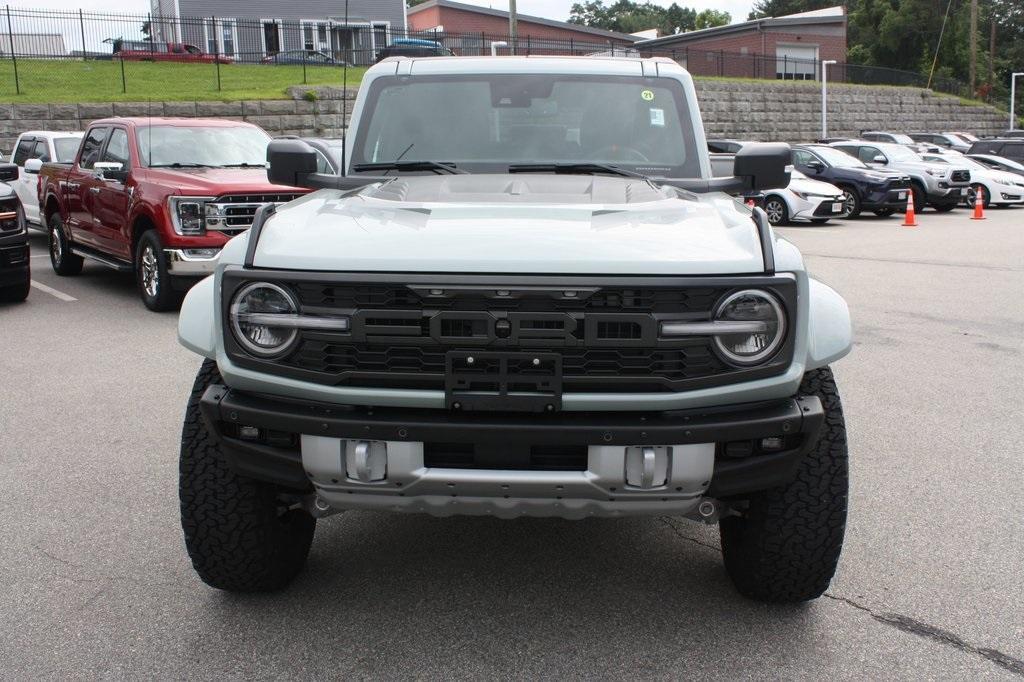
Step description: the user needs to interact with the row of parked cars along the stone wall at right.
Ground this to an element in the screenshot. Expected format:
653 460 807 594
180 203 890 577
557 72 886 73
708 131 1024 225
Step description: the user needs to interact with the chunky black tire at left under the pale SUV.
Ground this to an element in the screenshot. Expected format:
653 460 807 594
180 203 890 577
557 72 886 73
178 360 316 592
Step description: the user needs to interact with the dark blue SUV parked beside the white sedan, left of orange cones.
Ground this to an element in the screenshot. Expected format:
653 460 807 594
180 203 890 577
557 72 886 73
793 144 910 218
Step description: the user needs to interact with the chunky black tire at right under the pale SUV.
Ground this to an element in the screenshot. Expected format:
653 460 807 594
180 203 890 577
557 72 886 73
719 368 849 602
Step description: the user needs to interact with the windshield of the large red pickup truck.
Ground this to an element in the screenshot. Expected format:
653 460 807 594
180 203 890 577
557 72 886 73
136 126 270 168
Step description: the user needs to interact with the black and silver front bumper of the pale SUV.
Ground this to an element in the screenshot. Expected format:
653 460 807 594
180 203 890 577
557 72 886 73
201 385 823 518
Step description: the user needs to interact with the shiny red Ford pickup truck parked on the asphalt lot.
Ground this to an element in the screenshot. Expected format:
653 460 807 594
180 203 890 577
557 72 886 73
39 118 308 310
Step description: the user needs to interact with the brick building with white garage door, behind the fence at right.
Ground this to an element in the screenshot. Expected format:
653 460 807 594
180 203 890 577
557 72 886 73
636 7 846 80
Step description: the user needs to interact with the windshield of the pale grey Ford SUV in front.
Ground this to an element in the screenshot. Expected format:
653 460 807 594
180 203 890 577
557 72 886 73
352 74 700 177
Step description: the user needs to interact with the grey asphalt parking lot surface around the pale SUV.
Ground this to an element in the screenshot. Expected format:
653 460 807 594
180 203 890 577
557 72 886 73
0 209 1024 679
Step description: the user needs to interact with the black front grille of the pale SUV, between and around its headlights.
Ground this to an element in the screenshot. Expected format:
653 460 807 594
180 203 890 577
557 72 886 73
223 271 796 393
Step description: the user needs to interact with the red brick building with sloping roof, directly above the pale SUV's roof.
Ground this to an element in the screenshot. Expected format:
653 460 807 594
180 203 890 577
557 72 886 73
408 0 638 54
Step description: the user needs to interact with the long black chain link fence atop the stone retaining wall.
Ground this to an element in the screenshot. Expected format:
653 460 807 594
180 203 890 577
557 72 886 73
0 6 972 102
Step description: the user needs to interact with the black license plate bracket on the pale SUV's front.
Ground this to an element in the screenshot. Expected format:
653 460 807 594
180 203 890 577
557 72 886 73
444 350 562 412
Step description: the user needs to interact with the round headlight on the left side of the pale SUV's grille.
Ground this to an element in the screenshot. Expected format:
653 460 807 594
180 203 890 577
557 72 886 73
230 282 299 357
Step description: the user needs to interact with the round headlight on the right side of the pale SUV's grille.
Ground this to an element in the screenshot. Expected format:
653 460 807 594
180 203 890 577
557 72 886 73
715 289 785 365
